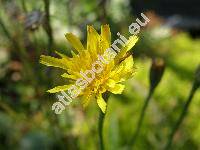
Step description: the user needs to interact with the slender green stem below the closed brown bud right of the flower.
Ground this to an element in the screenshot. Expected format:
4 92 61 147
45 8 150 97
131 88 154 146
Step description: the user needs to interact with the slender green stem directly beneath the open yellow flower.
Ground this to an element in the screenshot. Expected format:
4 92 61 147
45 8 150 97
98 110 105 150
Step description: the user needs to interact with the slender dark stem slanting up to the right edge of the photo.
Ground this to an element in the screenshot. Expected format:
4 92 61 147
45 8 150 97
165 84 198 150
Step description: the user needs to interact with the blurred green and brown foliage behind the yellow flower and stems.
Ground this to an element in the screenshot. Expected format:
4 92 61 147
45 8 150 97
0 0 200 150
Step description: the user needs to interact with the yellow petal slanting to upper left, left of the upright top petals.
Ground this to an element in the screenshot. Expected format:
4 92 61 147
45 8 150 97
65 33 84 52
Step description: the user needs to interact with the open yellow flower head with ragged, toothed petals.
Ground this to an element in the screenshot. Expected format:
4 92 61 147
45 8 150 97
40 25 138 113
